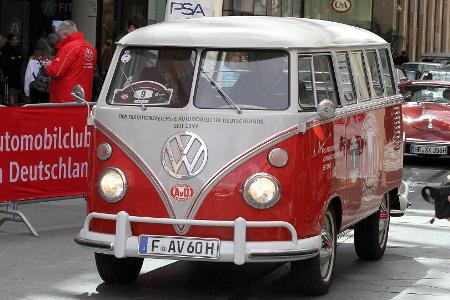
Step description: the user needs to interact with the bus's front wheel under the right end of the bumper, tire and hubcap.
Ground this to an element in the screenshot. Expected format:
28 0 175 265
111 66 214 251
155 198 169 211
291 207 337 296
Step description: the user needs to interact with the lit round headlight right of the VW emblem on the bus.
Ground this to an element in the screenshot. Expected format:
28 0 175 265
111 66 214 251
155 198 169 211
242 173 281 209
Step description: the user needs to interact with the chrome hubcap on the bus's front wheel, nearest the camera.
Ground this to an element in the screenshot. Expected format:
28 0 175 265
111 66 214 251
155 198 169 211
320 214 334 280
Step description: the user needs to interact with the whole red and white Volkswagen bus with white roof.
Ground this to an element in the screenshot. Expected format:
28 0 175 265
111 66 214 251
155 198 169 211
75 17 403 294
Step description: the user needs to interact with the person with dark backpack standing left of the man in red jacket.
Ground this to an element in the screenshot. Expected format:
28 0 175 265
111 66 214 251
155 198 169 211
23 38 52 103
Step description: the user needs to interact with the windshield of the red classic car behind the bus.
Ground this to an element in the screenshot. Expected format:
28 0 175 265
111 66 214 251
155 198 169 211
400 86 450 103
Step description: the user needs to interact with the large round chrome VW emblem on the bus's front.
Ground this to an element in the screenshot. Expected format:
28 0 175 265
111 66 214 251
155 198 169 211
161 132 208 179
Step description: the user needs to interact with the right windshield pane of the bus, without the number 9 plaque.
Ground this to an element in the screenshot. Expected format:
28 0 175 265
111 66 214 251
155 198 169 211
194 50 289 110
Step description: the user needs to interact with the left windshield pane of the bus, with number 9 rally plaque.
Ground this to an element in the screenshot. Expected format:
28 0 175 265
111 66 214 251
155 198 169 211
107 48 196 107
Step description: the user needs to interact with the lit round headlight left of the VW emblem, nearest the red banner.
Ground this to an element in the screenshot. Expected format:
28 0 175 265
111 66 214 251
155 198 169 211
98 168 128 203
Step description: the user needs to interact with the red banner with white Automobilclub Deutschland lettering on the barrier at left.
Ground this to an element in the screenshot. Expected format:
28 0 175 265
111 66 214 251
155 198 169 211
0 106 92 202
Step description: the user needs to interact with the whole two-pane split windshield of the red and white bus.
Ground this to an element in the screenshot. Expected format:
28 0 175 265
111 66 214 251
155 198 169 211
107 48 289 112
